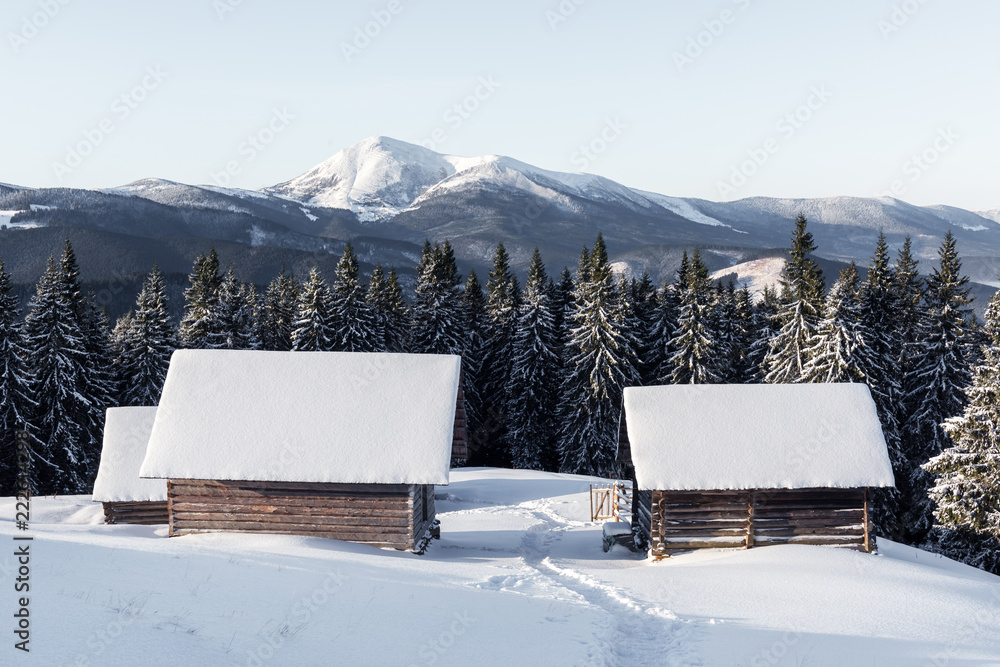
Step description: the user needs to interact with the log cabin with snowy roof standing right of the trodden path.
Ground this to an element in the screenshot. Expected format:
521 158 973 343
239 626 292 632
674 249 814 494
619 383 894 558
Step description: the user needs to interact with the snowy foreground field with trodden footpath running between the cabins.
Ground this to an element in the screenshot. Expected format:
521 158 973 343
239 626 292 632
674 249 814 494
0 468 1000 666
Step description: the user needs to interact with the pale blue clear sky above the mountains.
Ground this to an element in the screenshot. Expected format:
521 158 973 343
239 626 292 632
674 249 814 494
0 0 1000 209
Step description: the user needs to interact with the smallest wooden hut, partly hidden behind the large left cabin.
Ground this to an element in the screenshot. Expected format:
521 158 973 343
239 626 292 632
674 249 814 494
94 407 167 524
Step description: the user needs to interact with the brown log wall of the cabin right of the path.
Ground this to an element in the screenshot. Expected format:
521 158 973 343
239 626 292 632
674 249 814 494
651 489 874 557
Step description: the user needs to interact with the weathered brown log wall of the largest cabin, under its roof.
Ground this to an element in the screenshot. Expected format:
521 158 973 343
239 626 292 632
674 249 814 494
167 479 433 549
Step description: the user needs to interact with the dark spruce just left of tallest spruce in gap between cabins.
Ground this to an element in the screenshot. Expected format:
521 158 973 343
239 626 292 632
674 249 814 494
507 248 561 470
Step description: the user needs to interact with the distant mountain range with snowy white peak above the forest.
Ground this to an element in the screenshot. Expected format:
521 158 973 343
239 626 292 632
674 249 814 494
0 137 1000 318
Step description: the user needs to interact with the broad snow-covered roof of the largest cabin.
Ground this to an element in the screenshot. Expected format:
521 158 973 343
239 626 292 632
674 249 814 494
141 350 461 484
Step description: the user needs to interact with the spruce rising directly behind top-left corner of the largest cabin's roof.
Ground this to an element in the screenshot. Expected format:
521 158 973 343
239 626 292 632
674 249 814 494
178 248 226 349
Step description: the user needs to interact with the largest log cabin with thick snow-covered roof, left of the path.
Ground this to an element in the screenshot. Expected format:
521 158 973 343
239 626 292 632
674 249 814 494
141 350 465 551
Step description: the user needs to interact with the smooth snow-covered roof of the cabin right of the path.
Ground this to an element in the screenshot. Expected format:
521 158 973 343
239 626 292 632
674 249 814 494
625 383 893 491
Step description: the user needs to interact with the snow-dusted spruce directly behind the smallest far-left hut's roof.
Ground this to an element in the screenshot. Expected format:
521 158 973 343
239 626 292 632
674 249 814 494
118 264 177 405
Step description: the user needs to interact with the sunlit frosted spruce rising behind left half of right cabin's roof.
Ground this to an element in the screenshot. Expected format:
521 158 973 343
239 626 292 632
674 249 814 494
660 248 721 384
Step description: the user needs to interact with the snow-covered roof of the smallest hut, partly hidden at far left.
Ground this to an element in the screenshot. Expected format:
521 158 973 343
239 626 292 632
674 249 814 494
94 407 167 502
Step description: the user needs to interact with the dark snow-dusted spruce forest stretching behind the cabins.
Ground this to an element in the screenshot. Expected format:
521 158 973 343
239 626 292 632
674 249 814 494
0 215 1000 573
